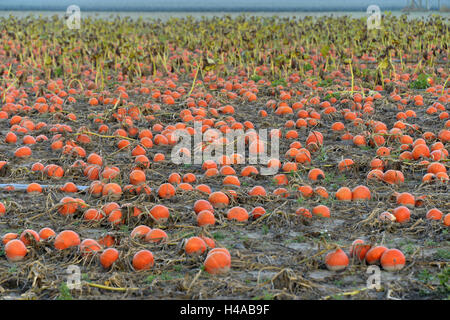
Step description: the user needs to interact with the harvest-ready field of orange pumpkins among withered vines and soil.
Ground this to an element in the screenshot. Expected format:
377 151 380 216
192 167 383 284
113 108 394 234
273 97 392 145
0 14 450 300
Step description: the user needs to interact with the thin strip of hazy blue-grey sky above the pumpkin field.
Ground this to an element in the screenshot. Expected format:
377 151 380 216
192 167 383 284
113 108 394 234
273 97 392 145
0 0 444 11
